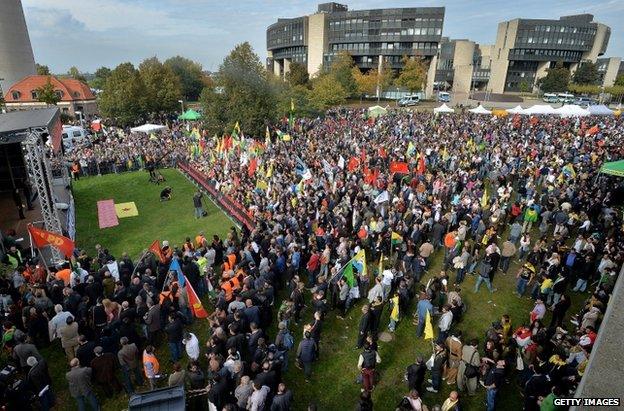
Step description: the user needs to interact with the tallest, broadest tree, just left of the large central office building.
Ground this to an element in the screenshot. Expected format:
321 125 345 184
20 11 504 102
201 42 283 136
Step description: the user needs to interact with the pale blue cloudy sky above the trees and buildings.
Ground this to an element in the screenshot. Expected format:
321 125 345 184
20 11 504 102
22 0 624 73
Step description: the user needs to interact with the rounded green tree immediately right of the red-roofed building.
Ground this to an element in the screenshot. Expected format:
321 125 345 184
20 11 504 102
99 63 146 126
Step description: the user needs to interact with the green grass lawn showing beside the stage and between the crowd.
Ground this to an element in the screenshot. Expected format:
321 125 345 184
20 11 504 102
43 170 582 410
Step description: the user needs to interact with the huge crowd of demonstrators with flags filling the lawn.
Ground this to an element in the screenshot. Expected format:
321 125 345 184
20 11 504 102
0 110 624 410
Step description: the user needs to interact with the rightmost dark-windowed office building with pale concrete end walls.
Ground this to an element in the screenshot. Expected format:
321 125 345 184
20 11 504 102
487 14 611 93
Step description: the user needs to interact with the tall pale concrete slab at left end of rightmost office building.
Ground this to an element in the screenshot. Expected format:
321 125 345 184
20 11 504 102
487 19 518 93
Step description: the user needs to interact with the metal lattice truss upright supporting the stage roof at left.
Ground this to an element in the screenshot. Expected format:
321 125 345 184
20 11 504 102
22 127 62 260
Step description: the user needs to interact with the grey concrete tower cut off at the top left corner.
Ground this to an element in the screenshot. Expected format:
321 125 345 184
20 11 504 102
0 0 35 93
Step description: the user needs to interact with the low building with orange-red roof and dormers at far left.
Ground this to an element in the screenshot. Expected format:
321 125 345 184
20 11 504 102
4 75 97 117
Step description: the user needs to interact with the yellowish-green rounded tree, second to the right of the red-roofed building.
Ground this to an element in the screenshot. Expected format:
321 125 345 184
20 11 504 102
139 57 182 113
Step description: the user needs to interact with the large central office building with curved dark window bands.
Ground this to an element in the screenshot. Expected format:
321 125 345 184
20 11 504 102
267 3 445 95
